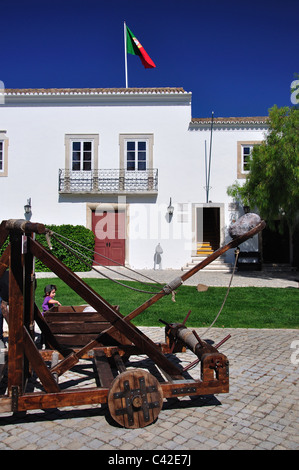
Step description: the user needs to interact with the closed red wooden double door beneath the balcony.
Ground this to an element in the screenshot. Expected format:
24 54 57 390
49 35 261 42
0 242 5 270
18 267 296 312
92 210 125 266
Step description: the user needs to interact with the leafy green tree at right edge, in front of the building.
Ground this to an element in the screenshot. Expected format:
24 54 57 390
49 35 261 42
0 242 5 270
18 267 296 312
227 105 299 262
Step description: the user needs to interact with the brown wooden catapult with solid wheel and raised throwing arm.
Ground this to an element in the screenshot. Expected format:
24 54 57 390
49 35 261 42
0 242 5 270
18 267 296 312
0 214 265 428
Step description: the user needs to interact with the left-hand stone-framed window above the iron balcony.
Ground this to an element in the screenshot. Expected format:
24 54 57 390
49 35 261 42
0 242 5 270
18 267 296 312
65 134 99 171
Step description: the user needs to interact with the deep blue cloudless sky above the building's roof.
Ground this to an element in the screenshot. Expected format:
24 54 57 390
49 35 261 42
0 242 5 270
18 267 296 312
0 0 299 117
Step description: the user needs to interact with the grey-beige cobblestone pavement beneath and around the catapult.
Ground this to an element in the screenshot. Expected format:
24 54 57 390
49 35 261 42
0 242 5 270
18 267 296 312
0 327 299 452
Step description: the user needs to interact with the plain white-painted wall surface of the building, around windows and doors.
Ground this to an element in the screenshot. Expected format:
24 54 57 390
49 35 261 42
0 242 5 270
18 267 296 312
0 92 264 268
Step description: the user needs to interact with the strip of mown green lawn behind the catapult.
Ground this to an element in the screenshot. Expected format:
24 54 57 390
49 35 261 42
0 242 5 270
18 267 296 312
36 278 299 328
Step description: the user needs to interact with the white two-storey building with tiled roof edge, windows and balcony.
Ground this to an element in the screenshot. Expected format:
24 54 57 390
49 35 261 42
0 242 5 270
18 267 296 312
0 88 267 269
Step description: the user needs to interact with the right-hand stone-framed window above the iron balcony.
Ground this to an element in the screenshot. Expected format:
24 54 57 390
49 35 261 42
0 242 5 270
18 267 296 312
119 134 154 171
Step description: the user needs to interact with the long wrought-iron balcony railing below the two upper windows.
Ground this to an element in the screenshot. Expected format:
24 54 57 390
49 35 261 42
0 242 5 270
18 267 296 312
58 168 158 194
